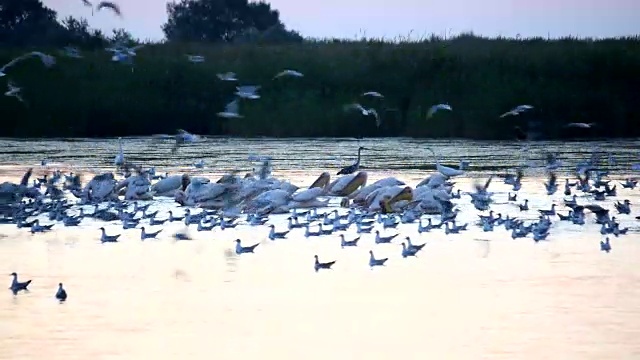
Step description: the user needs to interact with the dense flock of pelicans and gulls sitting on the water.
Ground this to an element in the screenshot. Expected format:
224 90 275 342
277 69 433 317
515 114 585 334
0 139 640 301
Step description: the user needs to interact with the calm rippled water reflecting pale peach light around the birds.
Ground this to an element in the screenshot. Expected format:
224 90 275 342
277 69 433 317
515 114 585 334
0 139 640 360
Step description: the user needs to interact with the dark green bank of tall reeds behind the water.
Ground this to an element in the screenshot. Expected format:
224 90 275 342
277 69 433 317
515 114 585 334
0 35 640 139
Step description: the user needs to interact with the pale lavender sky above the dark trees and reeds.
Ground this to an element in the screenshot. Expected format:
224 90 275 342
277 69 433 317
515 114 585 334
42 0 640 40
